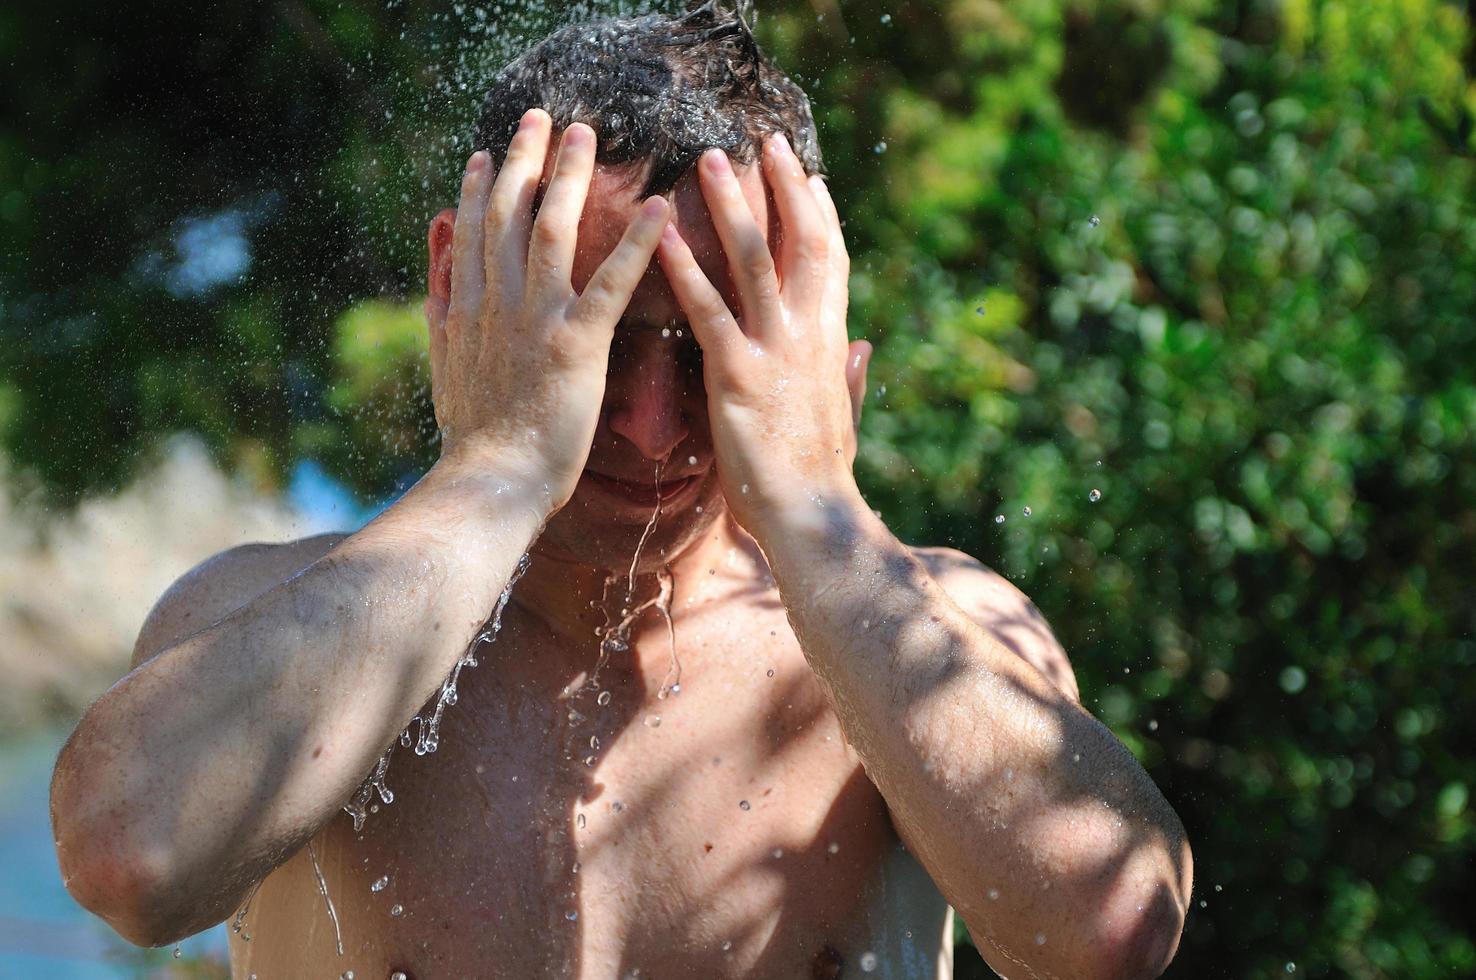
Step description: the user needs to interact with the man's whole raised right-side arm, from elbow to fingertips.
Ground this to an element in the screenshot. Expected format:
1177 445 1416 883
660 136 1191 979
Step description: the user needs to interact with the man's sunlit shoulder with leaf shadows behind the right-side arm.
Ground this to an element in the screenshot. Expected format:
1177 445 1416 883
911 548 1080 701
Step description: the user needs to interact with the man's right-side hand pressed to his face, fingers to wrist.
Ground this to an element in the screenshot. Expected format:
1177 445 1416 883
658 134 871 534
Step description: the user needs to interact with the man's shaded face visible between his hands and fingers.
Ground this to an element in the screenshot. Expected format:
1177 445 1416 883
536 155 775 570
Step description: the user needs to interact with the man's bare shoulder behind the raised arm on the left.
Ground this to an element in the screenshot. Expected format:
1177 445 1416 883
133 533 348 667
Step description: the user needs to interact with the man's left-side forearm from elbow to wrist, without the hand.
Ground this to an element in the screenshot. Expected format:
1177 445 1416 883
53 448 542 942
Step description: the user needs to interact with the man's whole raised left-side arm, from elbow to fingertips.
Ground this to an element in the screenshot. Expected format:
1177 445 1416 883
52 109 669 945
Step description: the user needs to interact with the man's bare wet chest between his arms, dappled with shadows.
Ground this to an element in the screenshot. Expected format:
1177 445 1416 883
230 608 896 977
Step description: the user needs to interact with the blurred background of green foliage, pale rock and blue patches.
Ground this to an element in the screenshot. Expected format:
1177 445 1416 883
0 0 1476 979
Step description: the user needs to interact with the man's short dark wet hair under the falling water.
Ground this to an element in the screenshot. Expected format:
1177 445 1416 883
472 0 824 196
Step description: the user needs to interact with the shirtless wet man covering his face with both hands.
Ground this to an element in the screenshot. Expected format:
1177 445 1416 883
52 7 1191 980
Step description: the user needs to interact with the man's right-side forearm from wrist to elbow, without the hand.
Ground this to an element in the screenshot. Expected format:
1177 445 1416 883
757 487 1190 977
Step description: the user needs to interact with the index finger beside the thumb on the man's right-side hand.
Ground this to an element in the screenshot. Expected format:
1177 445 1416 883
698 149 784 338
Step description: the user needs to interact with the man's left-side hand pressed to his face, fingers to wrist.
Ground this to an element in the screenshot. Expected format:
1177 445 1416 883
425 109 670 514
